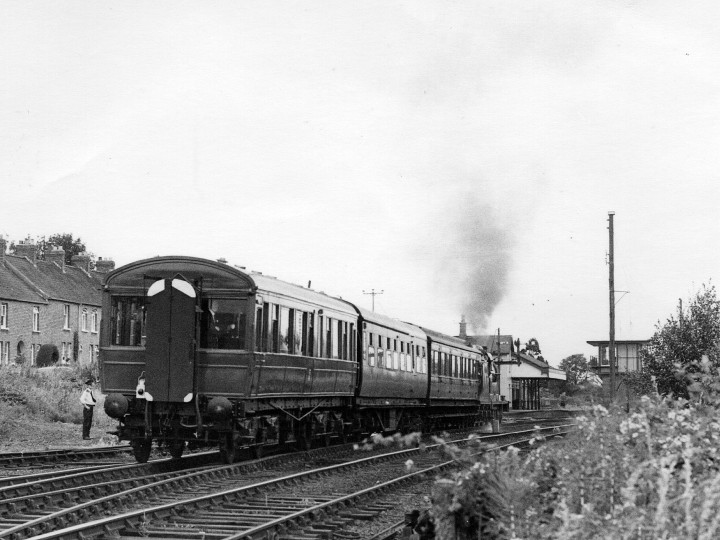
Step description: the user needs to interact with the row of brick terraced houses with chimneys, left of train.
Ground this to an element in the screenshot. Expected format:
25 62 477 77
0 238 115 368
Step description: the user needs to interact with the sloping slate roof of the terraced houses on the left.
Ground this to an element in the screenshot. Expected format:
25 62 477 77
0 254 102 306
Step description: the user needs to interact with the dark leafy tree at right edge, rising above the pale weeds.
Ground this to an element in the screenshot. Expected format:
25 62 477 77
641 284 720 398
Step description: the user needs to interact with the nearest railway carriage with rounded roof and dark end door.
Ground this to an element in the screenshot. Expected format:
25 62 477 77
100 257 357 462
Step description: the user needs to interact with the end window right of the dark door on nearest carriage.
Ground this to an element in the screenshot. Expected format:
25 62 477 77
200 298 246 349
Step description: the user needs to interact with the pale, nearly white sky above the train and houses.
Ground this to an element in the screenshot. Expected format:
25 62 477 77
0 0 720 365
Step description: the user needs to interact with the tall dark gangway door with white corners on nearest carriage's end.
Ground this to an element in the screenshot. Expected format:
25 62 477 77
145 278 197 403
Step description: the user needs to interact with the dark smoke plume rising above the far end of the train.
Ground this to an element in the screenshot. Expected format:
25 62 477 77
444 198 514 332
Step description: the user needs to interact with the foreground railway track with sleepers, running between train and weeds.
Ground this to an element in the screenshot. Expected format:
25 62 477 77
0 425 571 539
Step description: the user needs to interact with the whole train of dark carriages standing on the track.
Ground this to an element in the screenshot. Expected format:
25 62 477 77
100 256 502 463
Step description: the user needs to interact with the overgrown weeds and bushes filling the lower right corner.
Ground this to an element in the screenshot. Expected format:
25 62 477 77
424 286 720 540
